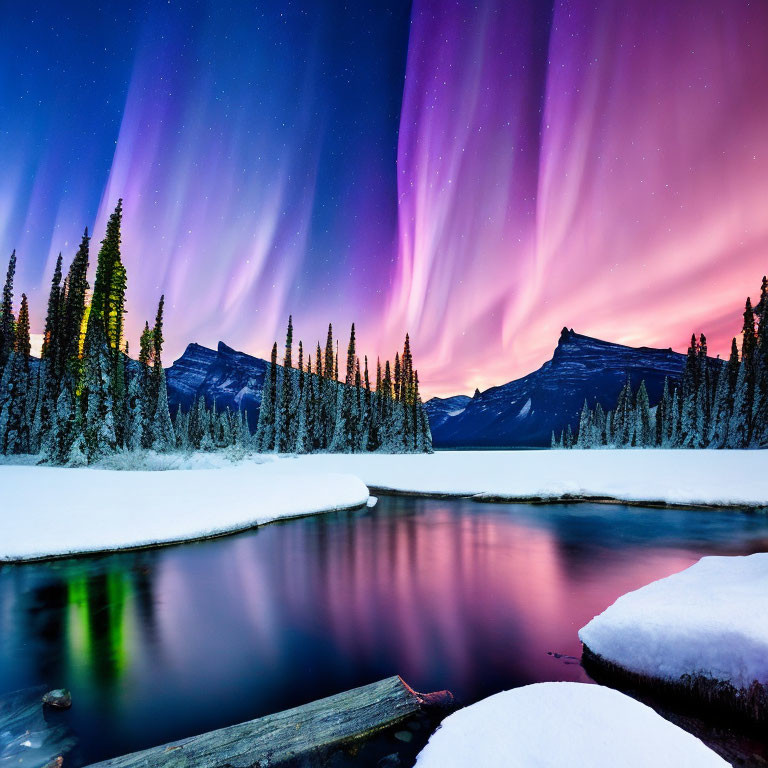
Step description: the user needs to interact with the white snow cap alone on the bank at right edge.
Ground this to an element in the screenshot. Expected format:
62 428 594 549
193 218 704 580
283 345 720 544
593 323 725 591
579 553 768 689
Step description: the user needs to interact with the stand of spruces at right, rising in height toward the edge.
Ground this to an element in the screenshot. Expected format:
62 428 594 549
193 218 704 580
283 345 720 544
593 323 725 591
552 277 768 448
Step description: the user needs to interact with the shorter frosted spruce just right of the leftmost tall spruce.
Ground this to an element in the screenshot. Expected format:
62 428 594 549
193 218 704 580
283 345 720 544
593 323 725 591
0 294 30 454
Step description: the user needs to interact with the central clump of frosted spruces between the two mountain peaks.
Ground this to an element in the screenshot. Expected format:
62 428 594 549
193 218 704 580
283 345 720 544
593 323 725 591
255 318 432 453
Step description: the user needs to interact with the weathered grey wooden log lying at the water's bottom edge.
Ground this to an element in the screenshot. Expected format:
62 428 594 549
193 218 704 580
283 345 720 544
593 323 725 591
86 675 454 768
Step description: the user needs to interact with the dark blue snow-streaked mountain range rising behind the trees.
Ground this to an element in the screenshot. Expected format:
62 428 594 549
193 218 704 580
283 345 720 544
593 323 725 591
166 328 712 448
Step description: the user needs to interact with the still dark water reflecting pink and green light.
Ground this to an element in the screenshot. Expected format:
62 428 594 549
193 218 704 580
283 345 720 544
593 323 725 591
0 497 768 763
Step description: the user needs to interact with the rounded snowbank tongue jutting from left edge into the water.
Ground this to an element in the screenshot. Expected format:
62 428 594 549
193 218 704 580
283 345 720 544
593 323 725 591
0 461 368 560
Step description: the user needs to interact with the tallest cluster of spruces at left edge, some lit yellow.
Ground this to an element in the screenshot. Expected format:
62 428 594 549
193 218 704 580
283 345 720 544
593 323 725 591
0 200 176 466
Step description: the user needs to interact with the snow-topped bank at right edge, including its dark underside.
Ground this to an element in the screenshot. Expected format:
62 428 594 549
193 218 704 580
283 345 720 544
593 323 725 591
579 553 768 730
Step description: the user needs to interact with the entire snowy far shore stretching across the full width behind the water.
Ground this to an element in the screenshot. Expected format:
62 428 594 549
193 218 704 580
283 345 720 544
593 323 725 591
0 450 768 561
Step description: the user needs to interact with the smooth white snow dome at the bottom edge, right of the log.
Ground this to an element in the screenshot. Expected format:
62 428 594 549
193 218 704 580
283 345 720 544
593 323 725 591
416 683 728 768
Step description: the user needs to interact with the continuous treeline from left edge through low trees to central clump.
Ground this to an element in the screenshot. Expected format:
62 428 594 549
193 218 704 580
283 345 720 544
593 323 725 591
0 200 432 466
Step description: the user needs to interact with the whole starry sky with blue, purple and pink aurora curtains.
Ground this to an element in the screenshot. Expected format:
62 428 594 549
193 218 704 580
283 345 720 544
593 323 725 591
0 0 768 395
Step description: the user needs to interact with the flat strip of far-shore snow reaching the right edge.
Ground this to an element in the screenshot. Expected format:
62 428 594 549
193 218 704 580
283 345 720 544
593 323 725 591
284 450 768 507
